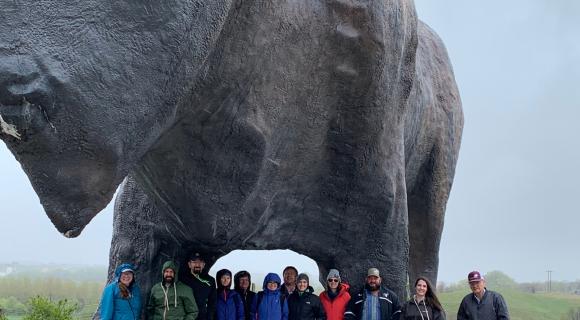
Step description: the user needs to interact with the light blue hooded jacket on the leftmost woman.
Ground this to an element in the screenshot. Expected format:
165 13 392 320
100 263 141 320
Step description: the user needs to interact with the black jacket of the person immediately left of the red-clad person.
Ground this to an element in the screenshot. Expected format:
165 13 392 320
288 286 326 320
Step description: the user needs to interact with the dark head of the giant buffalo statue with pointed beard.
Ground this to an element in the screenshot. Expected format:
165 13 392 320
0 0 228 237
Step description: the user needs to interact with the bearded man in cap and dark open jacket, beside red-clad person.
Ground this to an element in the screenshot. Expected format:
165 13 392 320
344 268 401 320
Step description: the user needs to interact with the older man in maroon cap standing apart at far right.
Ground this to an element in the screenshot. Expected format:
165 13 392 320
457 271 510 320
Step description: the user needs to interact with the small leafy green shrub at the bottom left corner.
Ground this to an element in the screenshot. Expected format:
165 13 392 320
22 296 78 320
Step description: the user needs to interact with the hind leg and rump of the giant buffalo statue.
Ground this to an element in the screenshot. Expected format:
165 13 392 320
405 22 463 291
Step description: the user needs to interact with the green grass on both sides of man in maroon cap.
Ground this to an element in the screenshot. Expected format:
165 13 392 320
439 289 580 320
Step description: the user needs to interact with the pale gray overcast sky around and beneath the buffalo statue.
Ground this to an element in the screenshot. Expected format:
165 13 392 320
0 0 580 281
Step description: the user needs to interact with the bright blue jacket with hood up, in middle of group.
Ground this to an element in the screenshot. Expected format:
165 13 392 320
251 273 288 320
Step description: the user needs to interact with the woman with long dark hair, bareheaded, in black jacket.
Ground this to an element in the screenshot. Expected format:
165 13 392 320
401 277 445 320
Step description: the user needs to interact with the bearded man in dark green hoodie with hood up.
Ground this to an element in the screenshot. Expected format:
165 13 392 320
147 261 197 320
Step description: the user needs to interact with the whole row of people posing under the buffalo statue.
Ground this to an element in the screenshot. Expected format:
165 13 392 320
100 253 509 320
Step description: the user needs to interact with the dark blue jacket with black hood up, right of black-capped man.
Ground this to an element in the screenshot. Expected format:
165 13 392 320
216 269 245 320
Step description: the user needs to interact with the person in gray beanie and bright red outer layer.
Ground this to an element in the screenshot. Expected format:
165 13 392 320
320 269 350 320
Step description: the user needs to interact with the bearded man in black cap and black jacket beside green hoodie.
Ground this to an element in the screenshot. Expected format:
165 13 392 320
181 252 217 320
